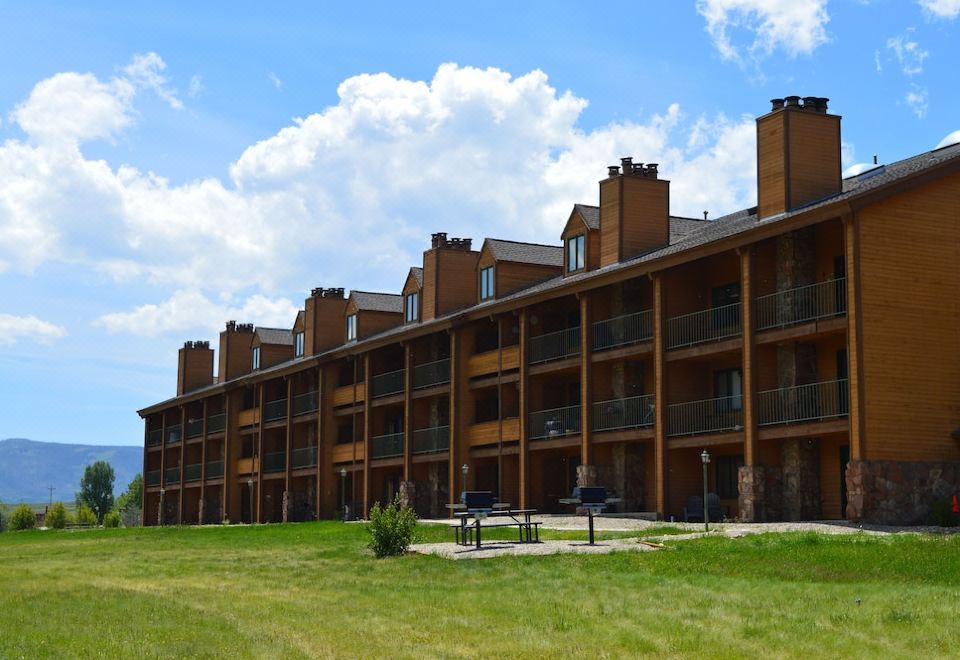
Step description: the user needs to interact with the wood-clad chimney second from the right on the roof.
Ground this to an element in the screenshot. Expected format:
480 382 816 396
600 157 670 267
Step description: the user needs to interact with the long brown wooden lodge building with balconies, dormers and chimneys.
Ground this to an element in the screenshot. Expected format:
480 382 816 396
139 97 960 525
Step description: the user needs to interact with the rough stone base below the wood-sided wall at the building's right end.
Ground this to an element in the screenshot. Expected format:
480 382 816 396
846 461 960 525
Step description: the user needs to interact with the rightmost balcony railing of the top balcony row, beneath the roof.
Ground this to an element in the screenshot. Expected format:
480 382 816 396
754 277 847 330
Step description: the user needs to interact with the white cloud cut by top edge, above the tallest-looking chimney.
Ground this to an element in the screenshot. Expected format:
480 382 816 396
697 0 830 65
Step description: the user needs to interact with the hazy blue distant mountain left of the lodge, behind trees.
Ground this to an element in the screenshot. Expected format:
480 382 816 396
0 438 143 504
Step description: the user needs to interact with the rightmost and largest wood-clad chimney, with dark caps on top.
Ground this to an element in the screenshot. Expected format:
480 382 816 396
757 96 841 218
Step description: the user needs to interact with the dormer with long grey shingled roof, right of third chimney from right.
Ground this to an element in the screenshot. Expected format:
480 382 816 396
476 238 563 302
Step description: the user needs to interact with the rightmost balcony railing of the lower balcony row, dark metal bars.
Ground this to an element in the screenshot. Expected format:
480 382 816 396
757 378 850 426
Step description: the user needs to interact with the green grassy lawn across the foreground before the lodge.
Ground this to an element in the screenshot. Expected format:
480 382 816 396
0 522 960 659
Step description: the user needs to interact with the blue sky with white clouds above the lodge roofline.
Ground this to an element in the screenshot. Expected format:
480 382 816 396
0 0 960 444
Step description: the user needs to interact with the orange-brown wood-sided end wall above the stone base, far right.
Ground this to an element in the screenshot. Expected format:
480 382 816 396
859 175 960 461
